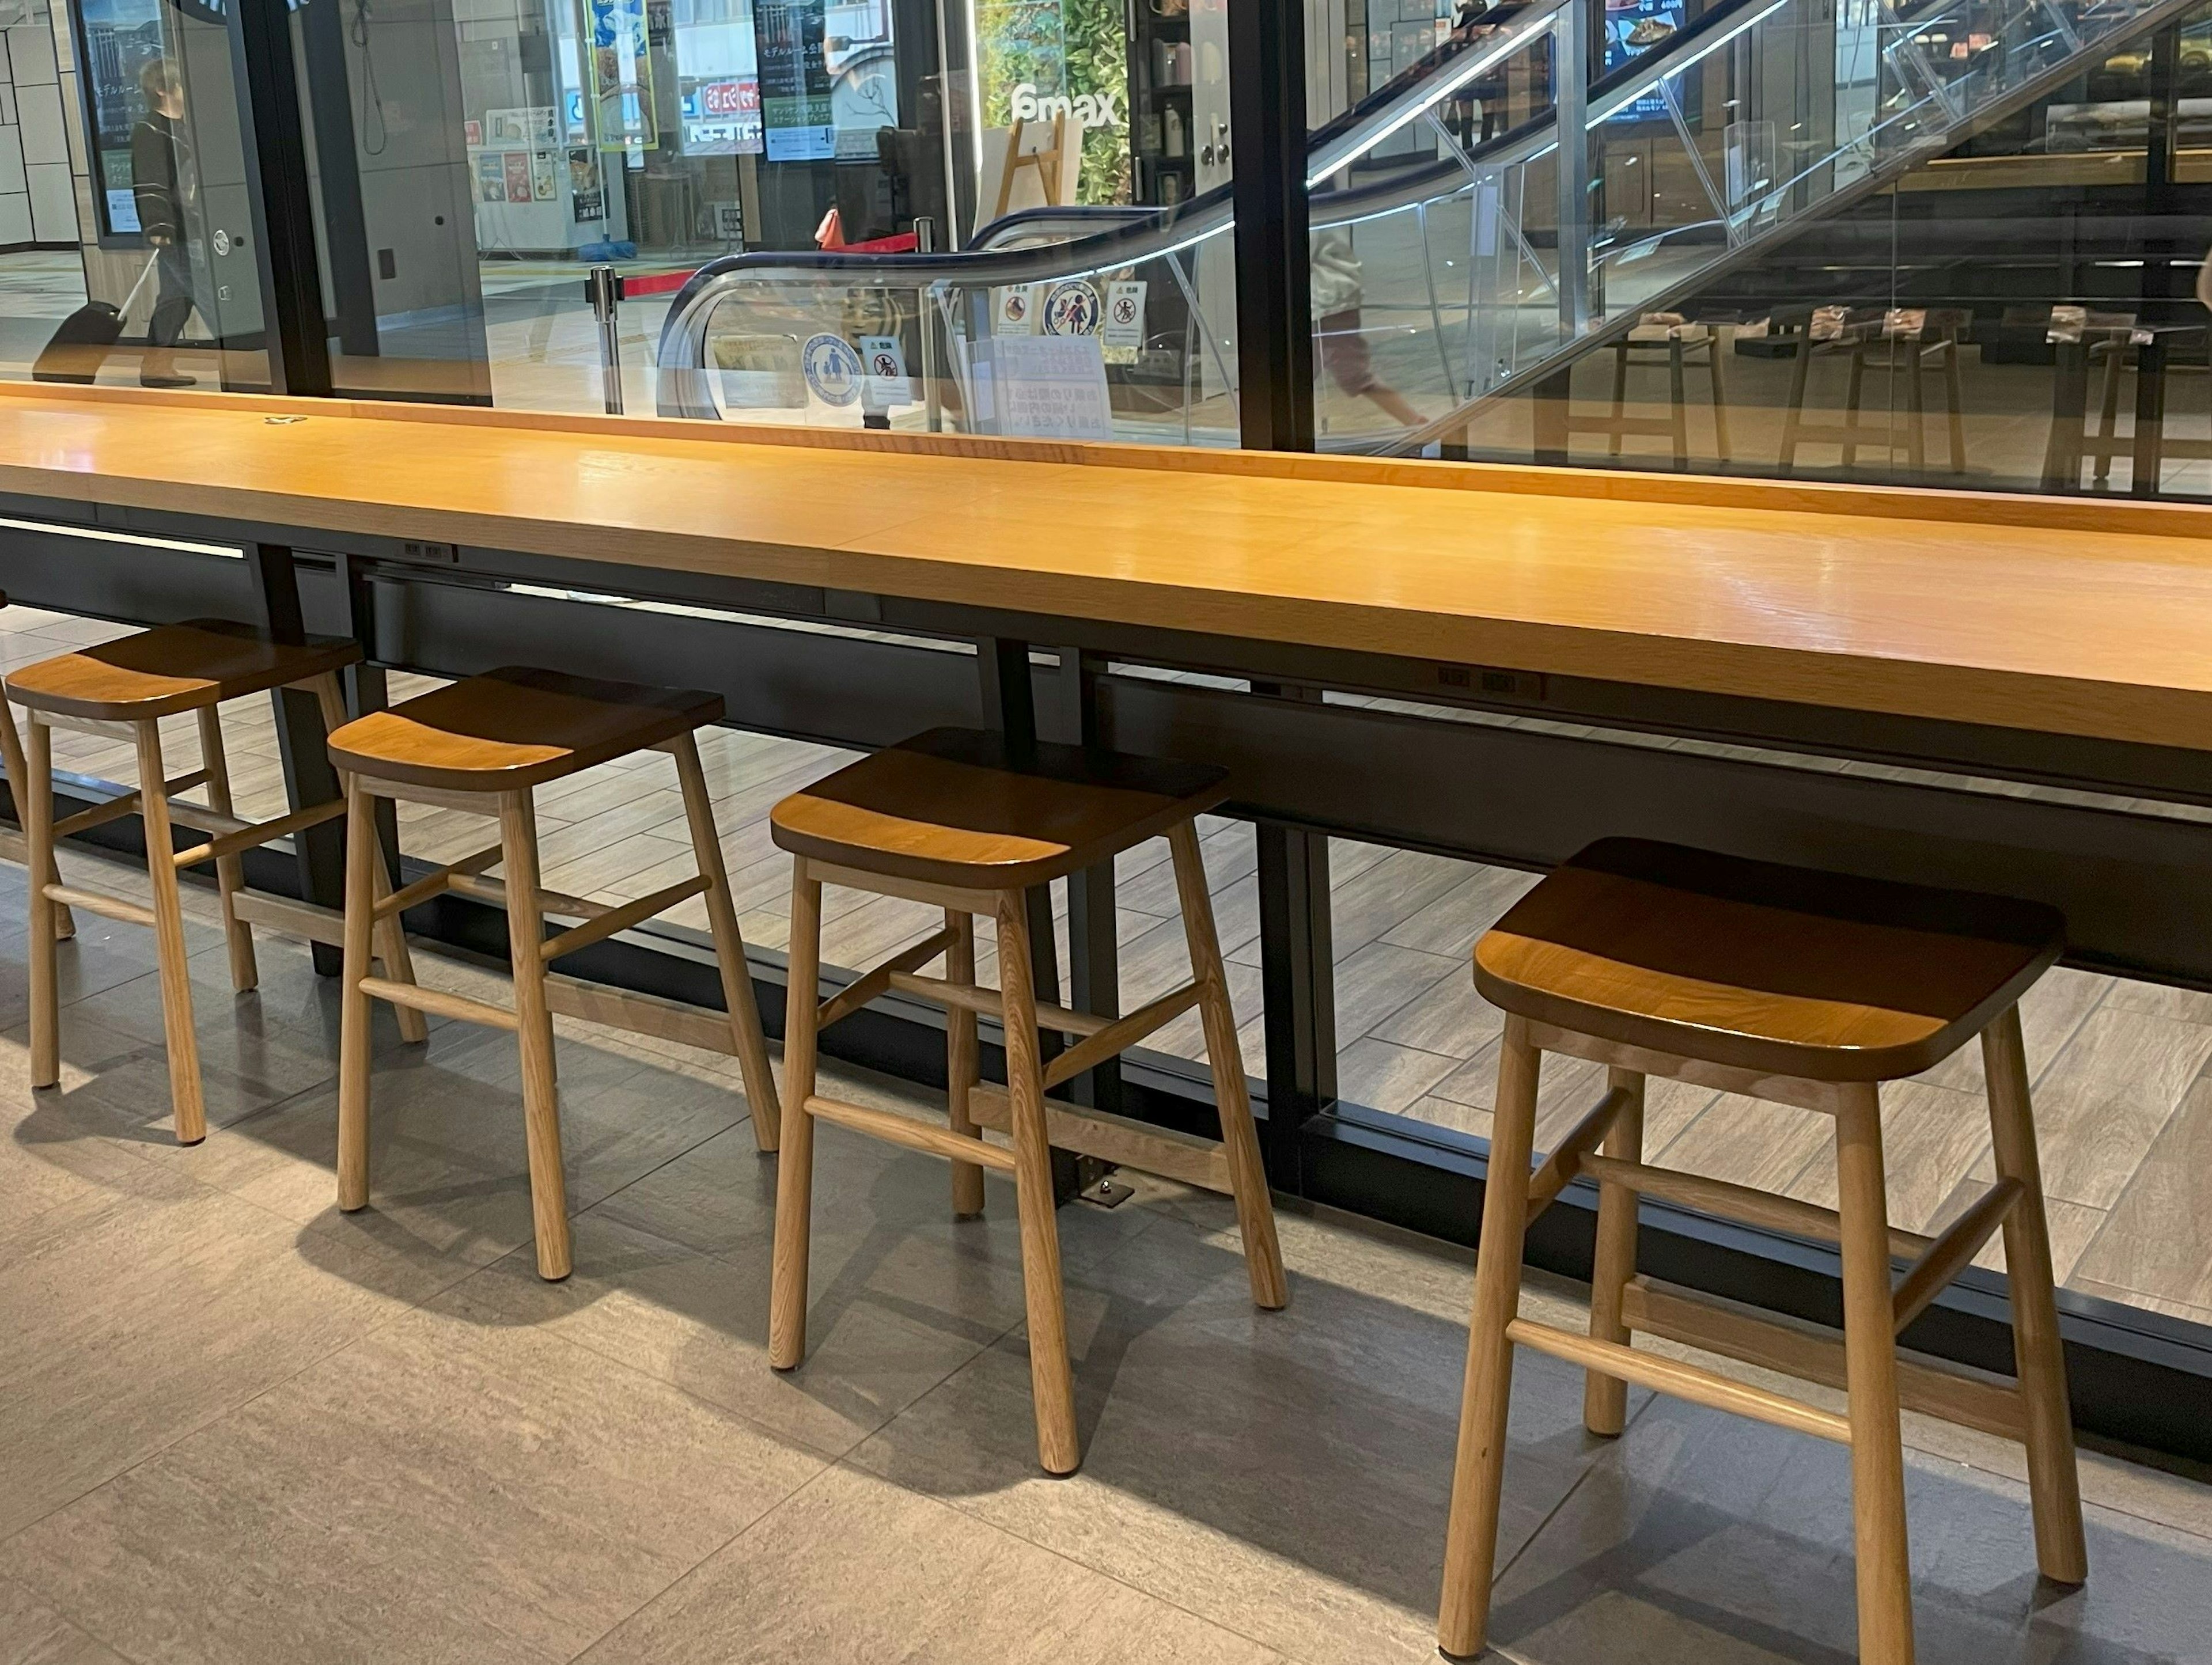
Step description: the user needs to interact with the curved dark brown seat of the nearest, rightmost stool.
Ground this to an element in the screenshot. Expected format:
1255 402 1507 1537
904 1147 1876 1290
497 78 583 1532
1475 838 2066 1081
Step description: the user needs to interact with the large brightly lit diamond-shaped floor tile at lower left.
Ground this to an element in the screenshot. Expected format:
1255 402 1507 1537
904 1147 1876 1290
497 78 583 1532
9 1296 823 1665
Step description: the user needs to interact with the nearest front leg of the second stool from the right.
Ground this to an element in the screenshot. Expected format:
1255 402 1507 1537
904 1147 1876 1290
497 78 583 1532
998 891 1082 1475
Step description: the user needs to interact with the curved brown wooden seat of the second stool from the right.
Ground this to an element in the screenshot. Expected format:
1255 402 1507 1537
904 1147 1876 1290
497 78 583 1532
770 727 1228 891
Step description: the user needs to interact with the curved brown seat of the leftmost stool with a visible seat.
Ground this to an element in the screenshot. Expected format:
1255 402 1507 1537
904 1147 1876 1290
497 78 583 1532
7 619 361 723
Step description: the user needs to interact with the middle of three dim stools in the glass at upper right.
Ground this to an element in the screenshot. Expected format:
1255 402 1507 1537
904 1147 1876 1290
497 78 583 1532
1774 308 1973 473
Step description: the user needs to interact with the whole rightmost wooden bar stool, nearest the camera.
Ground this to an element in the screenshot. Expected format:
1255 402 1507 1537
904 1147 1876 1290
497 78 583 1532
1438 838 2088 1665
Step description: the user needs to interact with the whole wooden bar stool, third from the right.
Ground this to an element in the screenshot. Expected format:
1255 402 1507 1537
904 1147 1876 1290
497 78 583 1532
329 667 779 1278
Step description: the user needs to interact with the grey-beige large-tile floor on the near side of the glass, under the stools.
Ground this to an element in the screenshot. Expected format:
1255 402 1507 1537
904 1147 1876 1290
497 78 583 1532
0 854 2212 1665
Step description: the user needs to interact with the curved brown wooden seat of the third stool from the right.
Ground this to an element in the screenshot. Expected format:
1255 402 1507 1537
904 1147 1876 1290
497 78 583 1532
329 666 724 791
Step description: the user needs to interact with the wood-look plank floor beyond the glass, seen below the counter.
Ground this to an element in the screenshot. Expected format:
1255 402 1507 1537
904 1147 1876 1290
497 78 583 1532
0 608 2212 1322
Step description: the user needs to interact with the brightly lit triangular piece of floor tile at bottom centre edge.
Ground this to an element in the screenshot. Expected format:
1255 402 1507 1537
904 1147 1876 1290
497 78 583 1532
584 1468 1281 1665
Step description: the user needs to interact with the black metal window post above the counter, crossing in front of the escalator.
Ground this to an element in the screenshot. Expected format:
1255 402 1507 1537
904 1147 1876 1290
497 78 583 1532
1228 0 1314 451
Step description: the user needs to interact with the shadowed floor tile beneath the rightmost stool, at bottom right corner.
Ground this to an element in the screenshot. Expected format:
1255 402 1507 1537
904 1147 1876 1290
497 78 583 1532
1491 1402 2212 1665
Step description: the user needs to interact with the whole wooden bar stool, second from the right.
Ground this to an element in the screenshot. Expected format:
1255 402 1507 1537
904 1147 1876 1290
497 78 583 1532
767 730 1285 1475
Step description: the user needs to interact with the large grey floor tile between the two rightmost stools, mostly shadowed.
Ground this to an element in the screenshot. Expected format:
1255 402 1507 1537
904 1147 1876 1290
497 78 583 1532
851 1223 1628 1665
